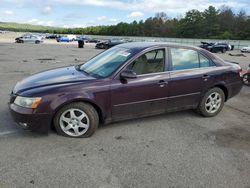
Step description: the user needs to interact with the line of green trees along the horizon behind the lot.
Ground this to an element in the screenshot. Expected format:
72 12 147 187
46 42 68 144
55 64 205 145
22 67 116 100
1 6 250 40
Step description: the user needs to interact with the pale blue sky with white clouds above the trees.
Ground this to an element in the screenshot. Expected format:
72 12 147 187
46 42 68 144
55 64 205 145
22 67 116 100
0 0 250 28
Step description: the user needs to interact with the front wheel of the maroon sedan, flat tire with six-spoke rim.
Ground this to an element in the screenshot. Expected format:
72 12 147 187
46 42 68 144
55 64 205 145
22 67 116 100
54 102 99 138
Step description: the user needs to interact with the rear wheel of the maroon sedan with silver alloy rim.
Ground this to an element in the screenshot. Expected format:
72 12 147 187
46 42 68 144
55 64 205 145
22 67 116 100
197 87 225 117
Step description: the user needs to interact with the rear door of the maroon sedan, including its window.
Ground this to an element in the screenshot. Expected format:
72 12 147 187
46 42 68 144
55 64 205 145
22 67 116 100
168 47 214 109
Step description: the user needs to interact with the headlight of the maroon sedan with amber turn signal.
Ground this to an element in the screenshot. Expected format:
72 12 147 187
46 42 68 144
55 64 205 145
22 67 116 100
14 96 42 109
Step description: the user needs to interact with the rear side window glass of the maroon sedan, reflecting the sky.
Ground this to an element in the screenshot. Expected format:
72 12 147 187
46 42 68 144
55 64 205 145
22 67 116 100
170 48 211 70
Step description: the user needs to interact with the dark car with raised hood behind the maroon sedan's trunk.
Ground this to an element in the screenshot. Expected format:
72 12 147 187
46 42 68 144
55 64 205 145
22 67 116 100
199 42 234 53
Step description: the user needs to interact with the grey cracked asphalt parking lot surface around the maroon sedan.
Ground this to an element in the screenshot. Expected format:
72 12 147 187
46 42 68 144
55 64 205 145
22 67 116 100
0 43 250 188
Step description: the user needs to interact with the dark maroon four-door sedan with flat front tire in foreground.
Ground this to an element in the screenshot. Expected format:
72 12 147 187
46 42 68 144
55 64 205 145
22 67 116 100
10 42 242 137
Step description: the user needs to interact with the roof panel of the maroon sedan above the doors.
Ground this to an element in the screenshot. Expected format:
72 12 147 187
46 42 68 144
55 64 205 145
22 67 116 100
118 42 200 51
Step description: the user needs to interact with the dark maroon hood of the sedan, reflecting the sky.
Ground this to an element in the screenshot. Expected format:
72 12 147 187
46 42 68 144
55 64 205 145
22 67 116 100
13 66 96 94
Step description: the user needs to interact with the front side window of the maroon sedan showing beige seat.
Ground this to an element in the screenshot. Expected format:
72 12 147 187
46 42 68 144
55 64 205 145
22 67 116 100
126 49 165 75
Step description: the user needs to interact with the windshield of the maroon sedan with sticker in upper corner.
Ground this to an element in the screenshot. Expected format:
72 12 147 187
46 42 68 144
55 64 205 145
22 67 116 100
80 47 133 78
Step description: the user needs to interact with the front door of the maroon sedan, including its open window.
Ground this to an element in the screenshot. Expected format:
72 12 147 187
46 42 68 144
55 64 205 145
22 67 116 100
111 48 169 121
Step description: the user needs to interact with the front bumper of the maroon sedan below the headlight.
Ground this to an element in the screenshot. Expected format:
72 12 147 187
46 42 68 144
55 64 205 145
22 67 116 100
9 103 52 134
